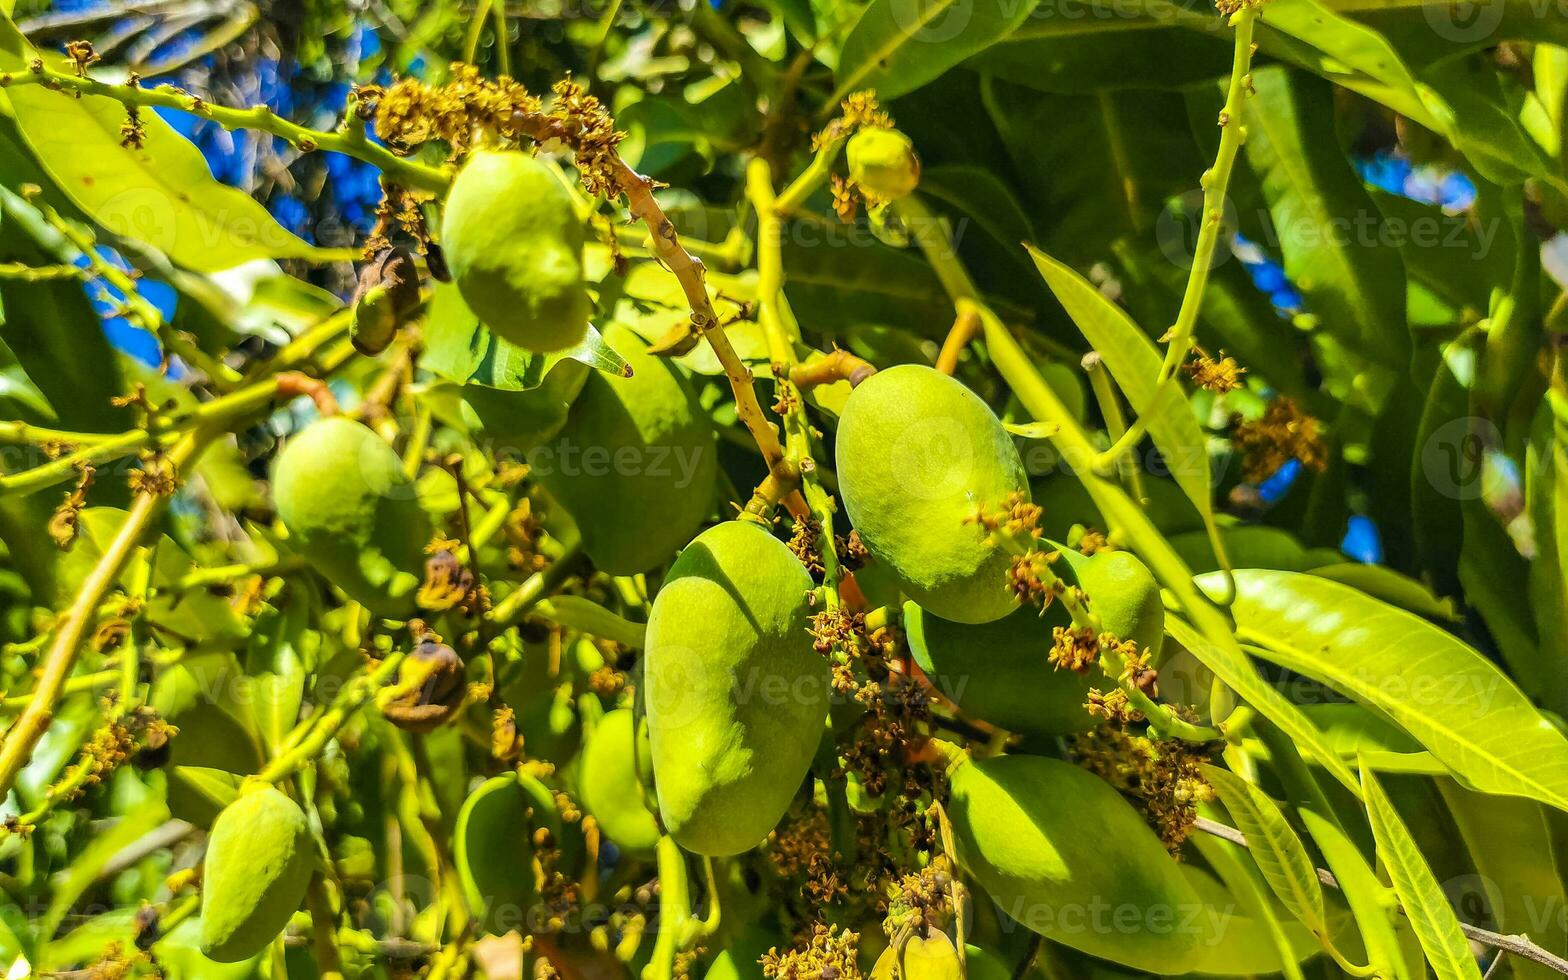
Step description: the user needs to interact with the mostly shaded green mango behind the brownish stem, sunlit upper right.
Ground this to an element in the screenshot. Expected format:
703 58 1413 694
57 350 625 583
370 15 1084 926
528 323 718 575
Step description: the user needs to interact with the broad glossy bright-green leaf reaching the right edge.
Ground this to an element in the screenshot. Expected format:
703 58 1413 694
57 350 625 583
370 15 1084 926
1204 569 1568 809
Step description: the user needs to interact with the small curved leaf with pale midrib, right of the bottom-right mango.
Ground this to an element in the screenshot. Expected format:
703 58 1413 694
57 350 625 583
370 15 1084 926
1203 765 1328 936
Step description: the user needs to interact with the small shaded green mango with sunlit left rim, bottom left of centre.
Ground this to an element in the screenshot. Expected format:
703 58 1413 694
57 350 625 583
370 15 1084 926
452 773 564 935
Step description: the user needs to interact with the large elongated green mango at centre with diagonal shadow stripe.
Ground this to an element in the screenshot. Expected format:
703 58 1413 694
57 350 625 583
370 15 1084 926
644 521 828 858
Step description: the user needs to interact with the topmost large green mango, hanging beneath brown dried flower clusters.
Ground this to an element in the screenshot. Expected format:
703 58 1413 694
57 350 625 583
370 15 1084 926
441 151 593 353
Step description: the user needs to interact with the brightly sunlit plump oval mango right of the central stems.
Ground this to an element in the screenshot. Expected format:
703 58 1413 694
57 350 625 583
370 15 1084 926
836 364 1029 622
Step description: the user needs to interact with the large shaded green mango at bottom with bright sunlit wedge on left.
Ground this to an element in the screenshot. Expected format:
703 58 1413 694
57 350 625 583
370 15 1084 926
947 756 1212 975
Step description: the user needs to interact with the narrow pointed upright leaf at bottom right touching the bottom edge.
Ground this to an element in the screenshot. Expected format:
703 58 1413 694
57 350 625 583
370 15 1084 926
1361 767 1480 980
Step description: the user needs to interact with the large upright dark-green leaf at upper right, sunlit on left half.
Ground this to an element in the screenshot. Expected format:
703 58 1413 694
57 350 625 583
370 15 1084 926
1243 66 1410 367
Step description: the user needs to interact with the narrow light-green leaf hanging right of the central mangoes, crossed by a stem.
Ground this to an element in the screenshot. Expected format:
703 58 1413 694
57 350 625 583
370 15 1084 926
1029 246 1225 564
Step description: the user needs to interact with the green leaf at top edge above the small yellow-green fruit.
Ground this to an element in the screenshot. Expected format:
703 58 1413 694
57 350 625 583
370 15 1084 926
829 0 1038 102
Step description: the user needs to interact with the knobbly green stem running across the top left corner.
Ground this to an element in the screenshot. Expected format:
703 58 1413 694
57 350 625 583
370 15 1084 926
0 67 452 194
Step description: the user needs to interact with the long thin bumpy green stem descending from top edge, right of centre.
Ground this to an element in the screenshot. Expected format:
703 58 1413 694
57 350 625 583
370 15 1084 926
1094 5 1258 469
